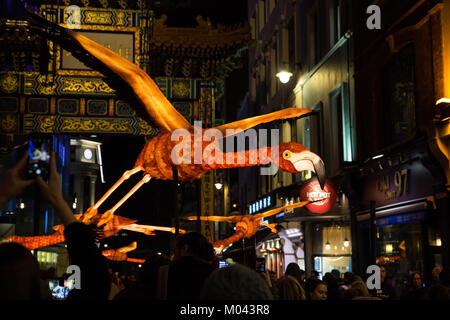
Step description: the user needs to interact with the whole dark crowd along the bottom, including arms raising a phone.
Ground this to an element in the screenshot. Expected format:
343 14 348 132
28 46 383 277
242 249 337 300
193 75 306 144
0 154 450 301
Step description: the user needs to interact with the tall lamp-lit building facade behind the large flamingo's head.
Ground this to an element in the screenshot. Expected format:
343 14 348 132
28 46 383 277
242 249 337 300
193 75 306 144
240 0 357 276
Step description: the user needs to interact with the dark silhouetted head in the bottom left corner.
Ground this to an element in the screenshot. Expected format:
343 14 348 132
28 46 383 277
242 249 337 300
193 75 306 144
0 242 41 300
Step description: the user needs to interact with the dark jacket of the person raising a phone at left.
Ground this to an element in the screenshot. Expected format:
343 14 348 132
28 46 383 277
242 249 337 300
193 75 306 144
64 222 111 300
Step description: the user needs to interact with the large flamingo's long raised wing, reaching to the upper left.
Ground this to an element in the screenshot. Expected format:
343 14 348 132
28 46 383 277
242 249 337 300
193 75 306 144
28 10 192 132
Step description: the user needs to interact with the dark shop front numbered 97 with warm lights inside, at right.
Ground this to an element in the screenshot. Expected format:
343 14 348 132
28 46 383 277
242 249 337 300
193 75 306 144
354 153 443 283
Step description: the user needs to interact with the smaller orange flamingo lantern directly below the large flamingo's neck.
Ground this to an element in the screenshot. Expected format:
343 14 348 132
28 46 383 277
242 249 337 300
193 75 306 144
186 201 311 252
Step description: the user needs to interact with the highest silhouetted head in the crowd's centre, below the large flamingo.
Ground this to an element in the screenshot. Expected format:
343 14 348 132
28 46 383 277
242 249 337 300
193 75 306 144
174 232 215 262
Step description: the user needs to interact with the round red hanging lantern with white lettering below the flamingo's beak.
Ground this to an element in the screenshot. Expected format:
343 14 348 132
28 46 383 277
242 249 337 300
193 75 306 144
300 177 336 214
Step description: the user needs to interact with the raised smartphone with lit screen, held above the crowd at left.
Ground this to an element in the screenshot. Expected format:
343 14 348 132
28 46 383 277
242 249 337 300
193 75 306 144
26 137 53 180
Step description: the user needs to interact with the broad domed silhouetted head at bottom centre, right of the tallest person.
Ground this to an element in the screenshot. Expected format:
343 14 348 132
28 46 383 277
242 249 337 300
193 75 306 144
200 263 273 300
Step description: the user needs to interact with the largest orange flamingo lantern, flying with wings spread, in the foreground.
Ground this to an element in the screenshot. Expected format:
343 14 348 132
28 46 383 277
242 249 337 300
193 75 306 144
29 11 325 229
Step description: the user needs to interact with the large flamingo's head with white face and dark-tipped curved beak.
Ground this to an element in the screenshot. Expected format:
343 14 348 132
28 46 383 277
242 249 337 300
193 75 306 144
279 142 325 189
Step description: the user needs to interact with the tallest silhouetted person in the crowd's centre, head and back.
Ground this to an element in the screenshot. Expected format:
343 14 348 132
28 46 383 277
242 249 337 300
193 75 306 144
167 232 215 300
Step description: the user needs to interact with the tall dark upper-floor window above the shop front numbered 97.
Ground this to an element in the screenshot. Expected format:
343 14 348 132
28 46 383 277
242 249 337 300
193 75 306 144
382 44 416 146
